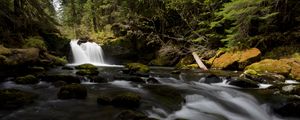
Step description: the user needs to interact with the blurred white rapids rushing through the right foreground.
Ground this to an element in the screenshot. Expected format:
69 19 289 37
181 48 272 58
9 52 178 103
147 82 283 120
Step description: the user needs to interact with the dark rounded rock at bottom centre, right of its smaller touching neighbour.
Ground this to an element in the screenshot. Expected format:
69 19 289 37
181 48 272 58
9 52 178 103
111 92 141 108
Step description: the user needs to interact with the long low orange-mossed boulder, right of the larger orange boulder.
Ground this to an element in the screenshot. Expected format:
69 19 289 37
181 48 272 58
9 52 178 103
246 59 292 75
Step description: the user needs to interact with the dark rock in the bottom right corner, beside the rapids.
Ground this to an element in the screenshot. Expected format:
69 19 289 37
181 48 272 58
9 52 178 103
275 101 300 117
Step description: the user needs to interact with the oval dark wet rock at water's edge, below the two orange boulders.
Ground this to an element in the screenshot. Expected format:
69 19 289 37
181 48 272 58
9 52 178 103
229 78 259 88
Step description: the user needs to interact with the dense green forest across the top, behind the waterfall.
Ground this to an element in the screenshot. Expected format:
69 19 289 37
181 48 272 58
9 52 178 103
0 0 300 64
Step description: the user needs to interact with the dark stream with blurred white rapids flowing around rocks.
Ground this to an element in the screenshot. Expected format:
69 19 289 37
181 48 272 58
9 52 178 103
0 66 296 120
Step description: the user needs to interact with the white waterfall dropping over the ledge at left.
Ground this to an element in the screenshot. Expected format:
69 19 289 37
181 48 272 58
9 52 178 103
70 40 105 65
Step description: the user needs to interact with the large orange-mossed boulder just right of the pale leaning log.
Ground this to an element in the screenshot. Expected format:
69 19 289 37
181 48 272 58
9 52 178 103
211 48 261 70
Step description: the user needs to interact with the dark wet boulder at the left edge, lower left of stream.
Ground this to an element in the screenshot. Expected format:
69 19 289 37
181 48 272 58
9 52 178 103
0 89 36 109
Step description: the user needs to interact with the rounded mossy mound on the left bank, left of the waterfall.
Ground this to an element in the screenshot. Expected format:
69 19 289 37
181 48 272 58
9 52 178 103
23 36 47 51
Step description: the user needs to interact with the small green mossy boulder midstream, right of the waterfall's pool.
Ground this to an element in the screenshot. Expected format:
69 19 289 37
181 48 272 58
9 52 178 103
125 63 150 73
